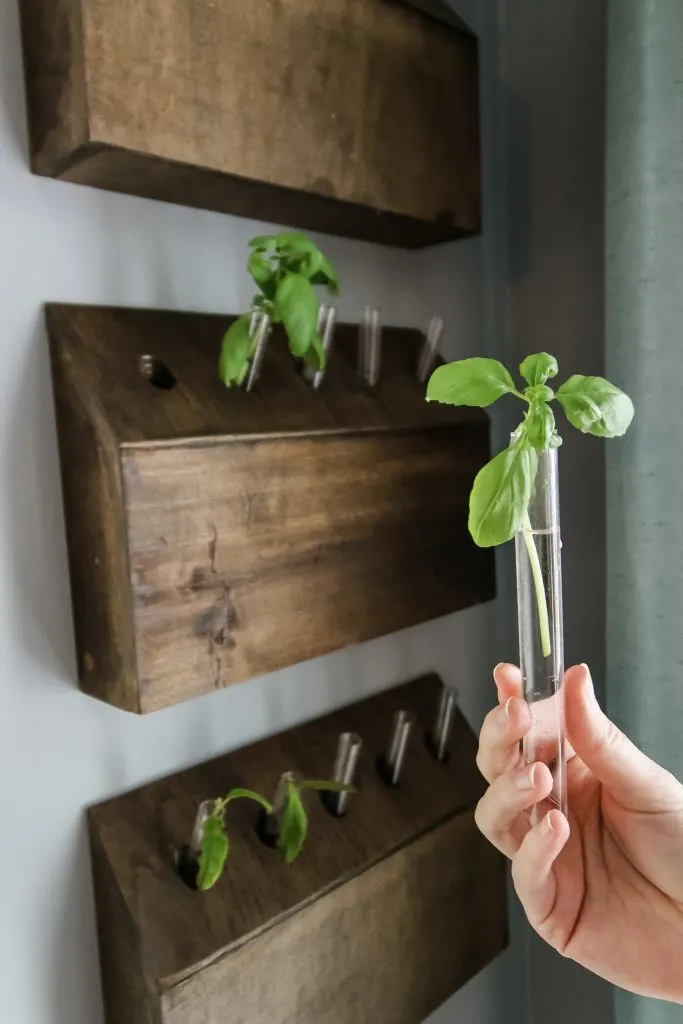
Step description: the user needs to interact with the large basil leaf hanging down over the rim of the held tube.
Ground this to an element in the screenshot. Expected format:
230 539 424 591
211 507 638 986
468 433 537 548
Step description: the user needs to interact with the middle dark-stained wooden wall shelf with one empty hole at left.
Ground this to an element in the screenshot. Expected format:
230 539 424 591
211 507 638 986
48 306 495 712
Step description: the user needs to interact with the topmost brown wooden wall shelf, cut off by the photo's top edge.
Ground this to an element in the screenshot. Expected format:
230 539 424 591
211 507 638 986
22 0 480 247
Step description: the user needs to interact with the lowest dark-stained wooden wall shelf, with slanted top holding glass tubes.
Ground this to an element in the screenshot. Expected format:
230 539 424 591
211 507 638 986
89 675 507 1024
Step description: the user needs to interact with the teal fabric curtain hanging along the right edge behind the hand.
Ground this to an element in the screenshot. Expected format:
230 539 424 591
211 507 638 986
610 0 683 1024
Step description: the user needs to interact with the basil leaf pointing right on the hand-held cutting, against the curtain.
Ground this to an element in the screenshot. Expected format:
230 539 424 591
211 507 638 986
557 374 634 437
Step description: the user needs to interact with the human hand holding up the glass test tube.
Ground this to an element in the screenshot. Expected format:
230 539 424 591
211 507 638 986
475 665 683 1002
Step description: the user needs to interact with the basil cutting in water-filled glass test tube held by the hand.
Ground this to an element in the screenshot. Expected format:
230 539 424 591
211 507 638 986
427 352 634 820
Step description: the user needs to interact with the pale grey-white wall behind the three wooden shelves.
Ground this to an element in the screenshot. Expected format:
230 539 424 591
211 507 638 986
0 0 524 1024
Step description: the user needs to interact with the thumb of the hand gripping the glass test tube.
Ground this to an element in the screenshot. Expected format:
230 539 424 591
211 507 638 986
564 665 673 811
